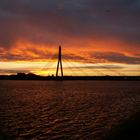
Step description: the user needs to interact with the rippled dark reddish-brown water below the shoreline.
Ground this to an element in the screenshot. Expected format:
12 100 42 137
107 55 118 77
0 81 140 140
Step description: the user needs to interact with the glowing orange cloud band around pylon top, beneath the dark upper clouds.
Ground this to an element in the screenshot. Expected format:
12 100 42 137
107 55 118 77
0 39 139 63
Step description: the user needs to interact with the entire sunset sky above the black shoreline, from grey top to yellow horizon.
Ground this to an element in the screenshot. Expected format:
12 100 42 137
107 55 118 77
0 0 140 75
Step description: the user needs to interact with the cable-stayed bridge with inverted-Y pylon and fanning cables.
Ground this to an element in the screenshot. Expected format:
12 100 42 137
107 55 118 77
41 46 126 77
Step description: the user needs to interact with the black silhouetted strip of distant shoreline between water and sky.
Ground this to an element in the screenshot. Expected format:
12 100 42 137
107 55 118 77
0 73 140 81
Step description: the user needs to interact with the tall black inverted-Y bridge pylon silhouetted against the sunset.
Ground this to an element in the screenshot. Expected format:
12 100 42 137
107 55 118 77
56 46 63 78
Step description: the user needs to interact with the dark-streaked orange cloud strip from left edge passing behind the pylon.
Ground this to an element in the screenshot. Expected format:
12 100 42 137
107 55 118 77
0 49 89 62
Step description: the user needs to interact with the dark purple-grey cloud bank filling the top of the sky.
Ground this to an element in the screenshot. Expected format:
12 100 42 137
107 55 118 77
0 0 140 47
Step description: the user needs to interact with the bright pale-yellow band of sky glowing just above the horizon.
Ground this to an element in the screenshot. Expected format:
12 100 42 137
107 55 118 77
0 61 140 76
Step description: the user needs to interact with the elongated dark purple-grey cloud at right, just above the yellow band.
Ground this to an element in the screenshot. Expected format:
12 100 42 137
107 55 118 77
91 52 140 64
